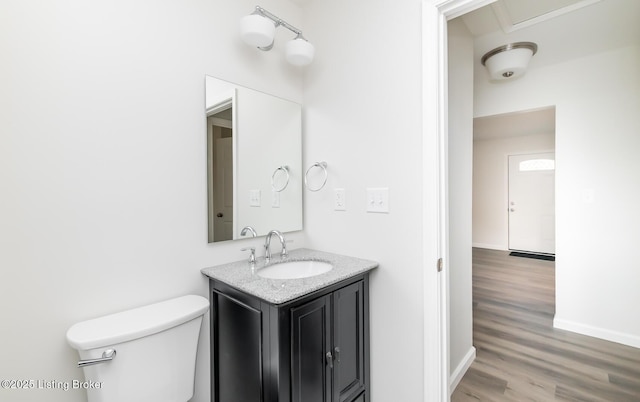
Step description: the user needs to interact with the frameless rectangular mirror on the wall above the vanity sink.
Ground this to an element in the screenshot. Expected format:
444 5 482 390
205 76 303 243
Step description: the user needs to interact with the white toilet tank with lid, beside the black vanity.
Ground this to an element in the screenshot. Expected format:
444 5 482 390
67 295 209 402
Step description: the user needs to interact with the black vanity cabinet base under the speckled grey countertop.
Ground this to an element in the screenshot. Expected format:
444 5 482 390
210 273 369 402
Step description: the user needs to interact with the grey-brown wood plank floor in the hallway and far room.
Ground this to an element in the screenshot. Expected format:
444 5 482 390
451 249 640 402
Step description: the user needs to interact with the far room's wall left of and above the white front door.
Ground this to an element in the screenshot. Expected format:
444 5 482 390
473 133 555 250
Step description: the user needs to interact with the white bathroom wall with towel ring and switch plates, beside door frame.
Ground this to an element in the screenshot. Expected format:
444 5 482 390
303 0 424 401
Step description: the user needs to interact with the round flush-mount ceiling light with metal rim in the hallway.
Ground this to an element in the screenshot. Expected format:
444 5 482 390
481 42 538 81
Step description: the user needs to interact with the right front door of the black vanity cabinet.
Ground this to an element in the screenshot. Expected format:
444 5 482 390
333 282 365 402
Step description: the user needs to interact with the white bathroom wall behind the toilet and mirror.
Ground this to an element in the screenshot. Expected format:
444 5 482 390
0 0 304 402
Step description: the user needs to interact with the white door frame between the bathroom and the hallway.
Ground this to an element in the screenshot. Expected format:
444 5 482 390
422 0 496 402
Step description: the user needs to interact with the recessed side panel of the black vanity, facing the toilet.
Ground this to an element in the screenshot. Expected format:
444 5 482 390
211 290 263 402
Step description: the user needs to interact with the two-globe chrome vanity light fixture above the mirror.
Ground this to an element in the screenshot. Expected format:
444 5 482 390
240 6 315 66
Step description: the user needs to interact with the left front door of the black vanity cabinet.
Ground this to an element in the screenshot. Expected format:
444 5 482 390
291 295 333 402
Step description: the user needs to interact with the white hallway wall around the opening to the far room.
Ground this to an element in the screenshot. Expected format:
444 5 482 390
475 46 640 347
